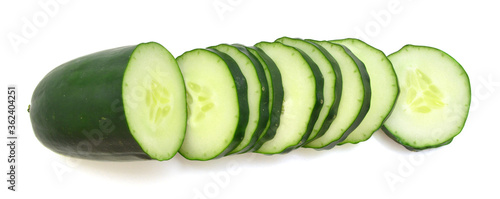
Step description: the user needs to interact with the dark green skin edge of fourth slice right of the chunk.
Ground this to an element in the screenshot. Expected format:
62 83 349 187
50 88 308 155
257 42 324 155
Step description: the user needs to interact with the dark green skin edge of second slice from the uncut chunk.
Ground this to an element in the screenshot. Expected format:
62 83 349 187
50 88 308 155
227 44 269 153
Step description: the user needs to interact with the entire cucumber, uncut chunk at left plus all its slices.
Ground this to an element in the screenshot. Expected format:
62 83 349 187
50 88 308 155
30 37 470 160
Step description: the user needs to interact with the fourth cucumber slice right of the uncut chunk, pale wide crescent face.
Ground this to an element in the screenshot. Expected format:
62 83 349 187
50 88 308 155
255 42 323 154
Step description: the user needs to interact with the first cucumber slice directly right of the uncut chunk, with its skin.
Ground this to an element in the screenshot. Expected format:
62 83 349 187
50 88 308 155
177 49 249 160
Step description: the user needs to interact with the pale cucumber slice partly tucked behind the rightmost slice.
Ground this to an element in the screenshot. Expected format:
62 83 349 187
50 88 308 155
331 39 399 144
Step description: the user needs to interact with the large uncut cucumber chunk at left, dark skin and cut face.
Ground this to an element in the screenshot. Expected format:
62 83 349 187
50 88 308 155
29 42 187 161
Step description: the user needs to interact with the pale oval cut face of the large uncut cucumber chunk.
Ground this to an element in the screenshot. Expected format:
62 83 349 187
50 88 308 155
122 43 187 160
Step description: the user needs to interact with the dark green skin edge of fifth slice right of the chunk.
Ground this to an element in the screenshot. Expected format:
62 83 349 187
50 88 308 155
276 37 342 144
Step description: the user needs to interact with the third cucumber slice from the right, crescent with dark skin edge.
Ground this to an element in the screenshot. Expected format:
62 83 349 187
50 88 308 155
304 40 371 149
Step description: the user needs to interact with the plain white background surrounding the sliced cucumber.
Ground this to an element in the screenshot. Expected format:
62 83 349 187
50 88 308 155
0 0 500 199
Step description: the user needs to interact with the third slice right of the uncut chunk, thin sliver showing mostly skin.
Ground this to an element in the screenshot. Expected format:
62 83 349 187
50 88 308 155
240 46 284 152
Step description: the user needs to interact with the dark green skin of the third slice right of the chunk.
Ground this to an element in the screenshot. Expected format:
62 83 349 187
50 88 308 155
246 46 284 152
